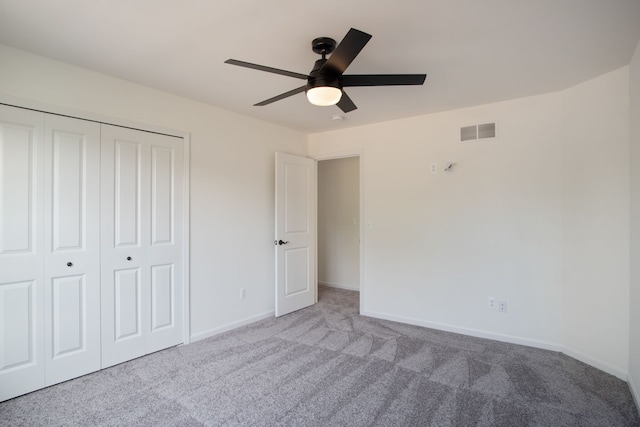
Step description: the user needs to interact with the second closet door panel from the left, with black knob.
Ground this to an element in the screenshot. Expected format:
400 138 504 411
44 115 100 385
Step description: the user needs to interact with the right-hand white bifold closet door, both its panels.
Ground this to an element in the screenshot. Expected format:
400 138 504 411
101 125 183 368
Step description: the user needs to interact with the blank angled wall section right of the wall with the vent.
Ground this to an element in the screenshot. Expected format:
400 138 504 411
562 67 629 377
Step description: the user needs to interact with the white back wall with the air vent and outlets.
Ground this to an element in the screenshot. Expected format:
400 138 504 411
309 94 562 346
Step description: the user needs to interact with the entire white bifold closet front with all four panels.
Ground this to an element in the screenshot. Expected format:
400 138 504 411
0 105 185 401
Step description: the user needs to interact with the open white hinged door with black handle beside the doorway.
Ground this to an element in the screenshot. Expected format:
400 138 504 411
275 153 317 316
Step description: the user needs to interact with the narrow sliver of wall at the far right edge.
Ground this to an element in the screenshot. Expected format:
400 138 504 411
629 42 640 408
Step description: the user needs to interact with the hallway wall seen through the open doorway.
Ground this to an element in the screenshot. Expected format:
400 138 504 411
318 157 360 290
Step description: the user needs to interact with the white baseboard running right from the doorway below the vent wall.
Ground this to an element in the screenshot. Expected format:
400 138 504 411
361 311 638 382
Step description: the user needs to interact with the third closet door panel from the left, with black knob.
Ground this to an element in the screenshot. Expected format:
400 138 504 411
101 125 150 368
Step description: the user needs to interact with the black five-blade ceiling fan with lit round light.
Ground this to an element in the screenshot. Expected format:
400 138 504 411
224 28 427 113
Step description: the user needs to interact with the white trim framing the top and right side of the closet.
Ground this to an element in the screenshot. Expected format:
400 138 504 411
0 94 191 344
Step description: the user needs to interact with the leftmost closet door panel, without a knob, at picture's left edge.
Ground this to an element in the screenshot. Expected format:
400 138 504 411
0 105 45 401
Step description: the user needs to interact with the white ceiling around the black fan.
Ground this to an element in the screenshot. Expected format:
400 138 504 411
0 0 640 133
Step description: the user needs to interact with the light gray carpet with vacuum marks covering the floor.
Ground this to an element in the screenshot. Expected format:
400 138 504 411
0 288 640 427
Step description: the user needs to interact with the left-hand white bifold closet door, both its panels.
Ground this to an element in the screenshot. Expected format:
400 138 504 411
0 106 100 401
